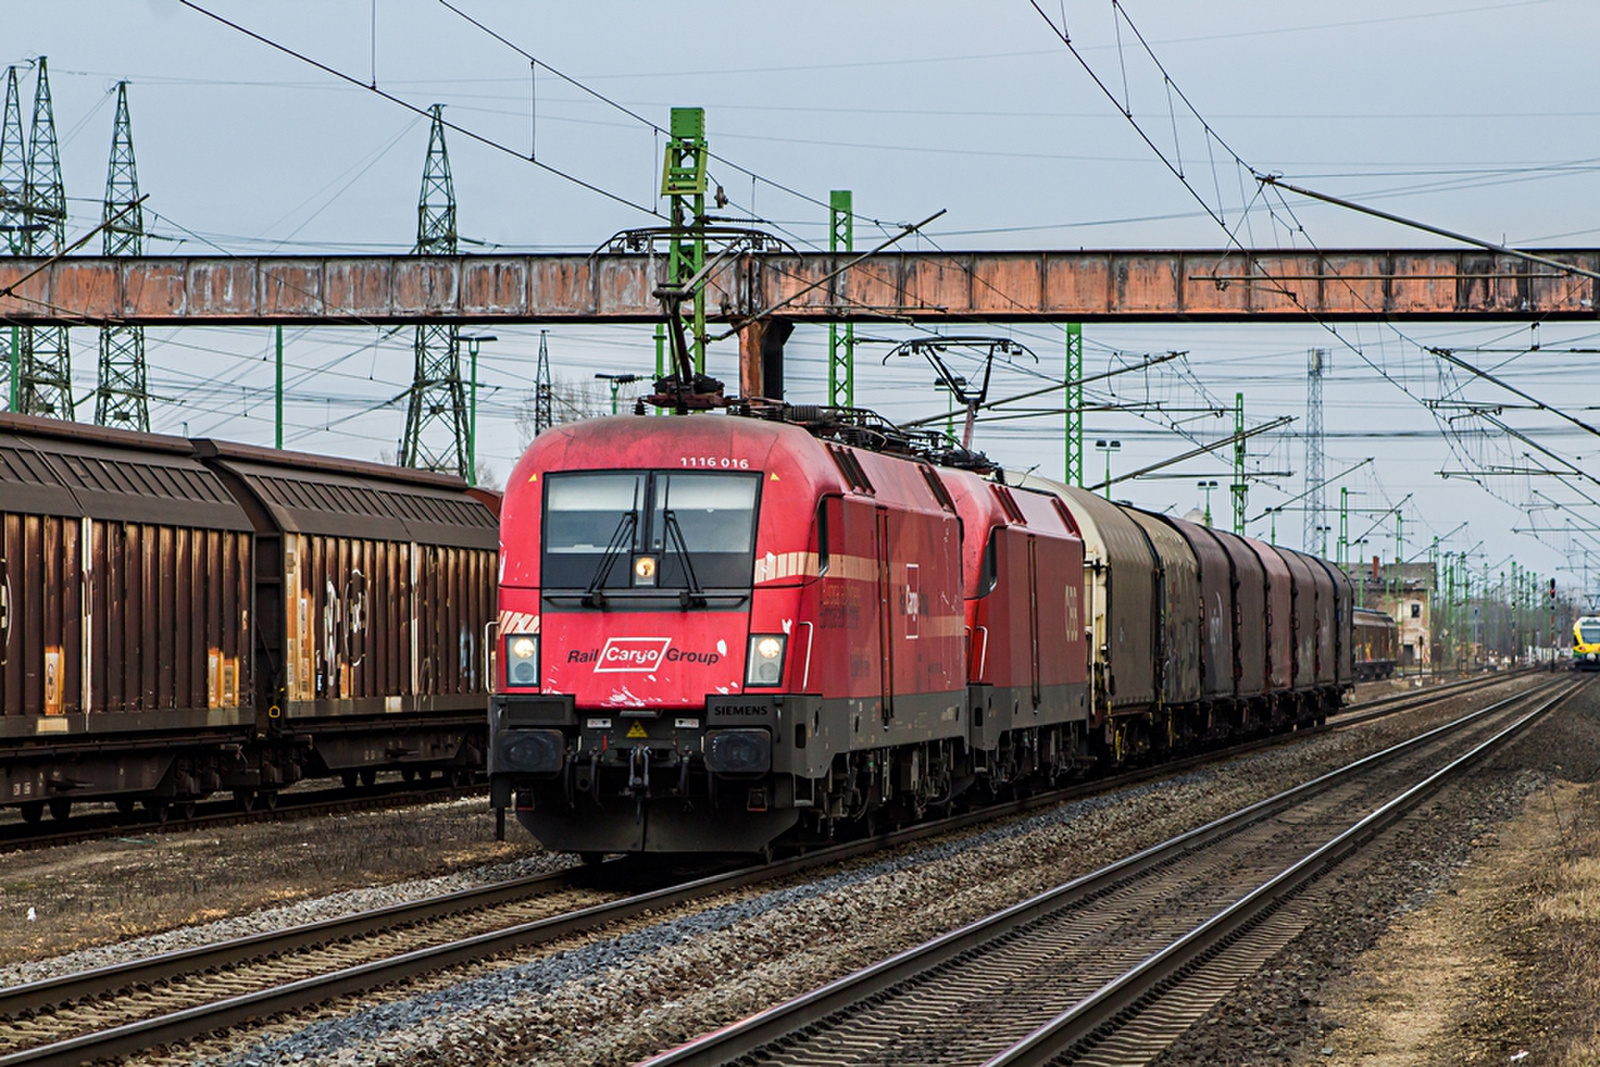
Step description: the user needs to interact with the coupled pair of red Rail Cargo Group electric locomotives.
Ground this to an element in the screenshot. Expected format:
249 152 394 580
490 416 1086 856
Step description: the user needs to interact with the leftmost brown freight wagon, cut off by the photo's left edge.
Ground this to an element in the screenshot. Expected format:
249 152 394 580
0 414 254 821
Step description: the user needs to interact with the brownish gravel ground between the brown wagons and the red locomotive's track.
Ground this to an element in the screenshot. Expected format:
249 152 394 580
0 798 556 985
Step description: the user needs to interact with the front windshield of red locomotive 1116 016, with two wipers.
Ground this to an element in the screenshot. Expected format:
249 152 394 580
542 470 760 606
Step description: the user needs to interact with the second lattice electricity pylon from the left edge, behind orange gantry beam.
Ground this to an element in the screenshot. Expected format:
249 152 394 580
18 56 72 419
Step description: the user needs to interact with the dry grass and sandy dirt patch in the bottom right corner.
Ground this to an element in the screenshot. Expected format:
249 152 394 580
1312 782 1600 1067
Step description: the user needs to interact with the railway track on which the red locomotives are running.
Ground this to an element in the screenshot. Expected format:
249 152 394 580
0 678 1548 1067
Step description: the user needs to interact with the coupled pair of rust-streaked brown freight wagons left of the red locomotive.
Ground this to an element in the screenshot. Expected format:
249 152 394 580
0 414 498 821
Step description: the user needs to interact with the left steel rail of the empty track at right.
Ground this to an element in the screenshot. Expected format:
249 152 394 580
640 675 1561 1067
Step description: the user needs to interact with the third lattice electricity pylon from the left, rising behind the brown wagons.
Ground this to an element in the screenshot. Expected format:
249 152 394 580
94 82 150 432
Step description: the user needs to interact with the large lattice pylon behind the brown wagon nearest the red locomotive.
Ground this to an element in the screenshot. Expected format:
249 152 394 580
400 104 472 478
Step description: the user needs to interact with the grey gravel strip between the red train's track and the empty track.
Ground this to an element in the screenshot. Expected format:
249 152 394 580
159 675 1548 1064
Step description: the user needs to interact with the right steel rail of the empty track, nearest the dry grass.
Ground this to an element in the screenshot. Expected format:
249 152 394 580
984 681 1584 1067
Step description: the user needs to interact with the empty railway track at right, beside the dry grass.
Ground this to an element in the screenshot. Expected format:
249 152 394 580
646 678 1584 1067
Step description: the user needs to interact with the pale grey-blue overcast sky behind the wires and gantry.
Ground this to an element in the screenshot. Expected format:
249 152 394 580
6 0 1600 601
